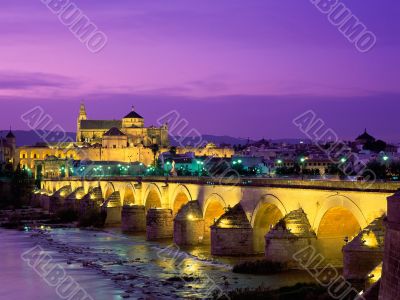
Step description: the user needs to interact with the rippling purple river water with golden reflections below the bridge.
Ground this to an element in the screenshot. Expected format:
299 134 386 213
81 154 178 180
0 229 318 300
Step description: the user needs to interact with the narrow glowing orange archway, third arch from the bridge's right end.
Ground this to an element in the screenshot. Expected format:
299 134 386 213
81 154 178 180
203 194 226 244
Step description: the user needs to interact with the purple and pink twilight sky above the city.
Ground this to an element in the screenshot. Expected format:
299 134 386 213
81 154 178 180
0 0 400 140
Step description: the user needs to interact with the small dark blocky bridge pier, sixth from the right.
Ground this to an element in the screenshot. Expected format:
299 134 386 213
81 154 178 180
121 205 146 232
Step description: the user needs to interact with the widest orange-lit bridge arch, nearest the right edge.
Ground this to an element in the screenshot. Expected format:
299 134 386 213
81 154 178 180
313 194 368 236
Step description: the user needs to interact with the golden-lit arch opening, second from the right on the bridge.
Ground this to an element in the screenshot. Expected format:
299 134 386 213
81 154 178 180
251 194 288 253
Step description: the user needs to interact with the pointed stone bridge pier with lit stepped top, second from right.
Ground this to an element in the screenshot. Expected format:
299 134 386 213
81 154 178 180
265 209 317 269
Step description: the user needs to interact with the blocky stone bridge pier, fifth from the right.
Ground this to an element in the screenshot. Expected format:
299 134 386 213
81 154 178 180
146 208 174 241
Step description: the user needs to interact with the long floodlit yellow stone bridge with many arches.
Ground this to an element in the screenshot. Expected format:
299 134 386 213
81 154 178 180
40 177 400 268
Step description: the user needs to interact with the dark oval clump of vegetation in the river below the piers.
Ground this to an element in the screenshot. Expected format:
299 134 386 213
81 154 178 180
232 259 287 275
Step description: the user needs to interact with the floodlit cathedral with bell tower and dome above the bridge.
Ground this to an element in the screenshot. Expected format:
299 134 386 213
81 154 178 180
76 103 169 148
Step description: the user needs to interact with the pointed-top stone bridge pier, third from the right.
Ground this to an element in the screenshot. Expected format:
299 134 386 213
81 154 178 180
211 203 254 256
